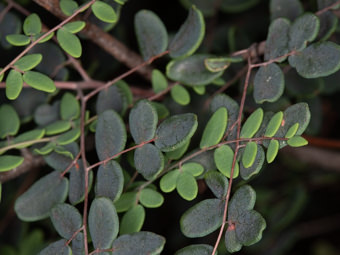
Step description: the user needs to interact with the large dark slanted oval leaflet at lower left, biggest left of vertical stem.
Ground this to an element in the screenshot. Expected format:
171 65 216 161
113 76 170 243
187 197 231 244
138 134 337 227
14 171 69 221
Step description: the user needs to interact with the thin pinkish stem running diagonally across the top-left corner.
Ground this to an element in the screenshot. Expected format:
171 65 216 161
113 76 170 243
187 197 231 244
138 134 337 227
0 0 96 75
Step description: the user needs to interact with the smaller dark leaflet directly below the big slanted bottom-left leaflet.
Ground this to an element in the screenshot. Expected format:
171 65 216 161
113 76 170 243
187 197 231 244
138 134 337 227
50 203 82 239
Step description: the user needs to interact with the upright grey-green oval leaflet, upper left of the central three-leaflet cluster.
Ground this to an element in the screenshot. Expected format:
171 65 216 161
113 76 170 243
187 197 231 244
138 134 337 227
129 100 158 144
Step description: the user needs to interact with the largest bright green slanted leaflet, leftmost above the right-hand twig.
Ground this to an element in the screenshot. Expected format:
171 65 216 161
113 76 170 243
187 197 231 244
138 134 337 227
200 107 228 149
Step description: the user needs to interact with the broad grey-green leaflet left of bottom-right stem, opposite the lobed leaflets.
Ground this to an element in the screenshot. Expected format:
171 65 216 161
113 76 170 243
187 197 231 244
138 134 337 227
180 199 224 238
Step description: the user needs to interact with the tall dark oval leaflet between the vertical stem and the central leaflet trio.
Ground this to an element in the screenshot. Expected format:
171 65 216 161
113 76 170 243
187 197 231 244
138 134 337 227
95 110 126 160
